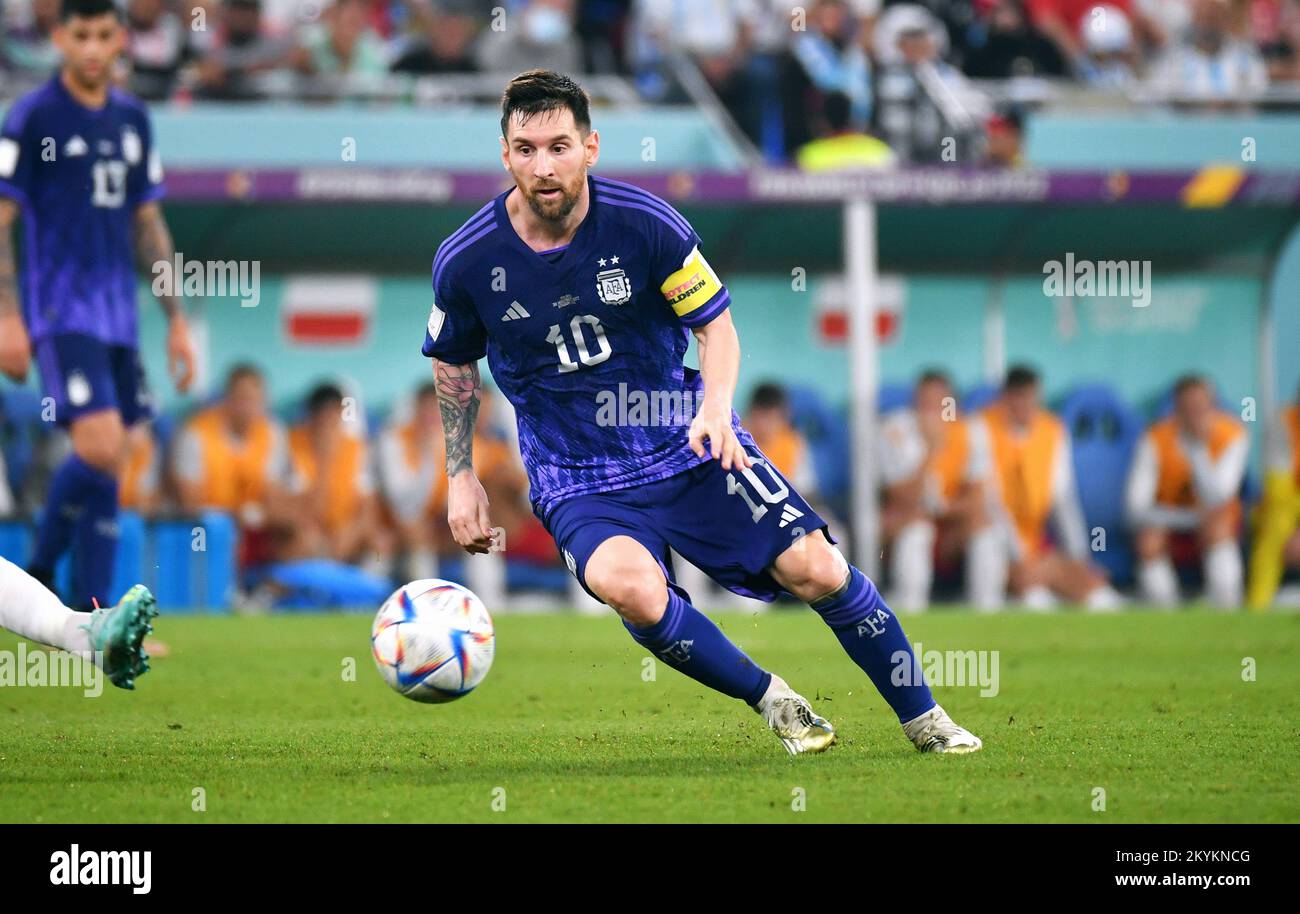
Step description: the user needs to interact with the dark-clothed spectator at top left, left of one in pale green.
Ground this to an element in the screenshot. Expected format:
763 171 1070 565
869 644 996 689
196 0 294 101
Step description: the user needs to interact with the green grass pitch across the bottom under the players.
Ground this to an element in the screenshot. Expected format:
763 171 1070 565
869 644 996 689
0 610 1300 823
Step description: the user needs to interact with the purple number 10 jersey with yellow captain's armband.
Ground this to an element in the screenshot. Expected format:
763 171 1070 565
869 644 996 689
424 177 753 517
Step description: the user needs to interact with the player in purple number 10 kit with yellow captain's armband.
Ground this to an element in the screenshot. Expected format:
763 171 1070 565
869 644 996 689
424 70 982 754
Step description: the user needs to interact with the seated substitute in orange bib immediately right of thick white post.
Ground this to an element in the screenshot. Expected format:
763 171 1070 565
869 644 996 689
879 371 1006 611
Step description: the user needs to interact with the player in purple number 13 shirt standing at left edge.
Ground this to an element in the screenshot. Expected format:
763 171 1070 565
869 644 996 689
0 0 185 675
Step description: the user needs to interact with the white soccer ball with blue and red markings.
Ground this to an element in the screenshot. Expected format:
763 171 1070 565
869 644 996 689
371 579 497 702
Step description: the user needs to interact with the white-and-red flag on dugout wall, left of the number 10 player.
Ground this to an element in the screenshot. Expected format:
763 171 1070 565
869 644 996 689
281 276 380 347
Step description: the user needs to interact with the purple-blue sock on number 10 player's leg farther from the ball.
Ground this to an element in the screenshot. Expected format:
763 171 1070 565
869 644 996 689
813 566 935 723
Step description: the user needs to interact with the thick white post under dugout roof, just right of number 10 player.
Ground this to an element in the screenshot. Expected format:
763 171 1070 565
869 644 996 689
844 196 880 580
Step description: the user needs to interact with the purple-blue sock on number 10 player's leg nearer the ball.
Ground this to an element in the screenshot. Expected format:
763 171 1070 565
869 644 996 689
623 588 772 705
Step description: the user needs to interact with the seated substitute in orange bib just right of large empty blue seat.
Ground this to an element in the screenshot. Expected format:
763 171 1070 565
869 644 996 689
1125 376 1251 607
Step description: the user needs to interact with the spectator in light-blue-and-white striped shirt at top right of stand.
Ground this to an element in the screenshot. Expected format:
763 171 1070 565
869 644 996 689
1149 0 1269 107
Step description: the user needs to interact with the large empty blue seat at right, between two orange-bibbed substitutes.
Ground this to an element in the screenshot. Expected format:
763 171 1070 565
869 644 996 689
1061 384 1143 582
